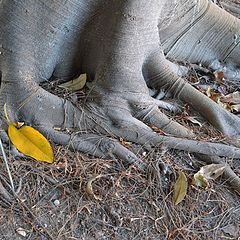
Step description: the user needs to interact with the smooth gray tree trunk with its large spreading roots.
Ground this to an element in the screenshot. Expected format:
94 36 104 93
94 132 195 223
0 0 240 190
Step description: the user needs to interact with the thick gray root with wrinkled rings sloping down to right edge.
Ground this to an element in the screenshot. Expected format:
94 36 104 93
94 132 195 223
145 51 240 137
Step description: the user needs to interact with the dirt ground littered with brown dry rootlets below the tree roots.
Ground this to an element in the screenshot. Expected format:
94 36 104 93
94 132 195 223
0 0 240 240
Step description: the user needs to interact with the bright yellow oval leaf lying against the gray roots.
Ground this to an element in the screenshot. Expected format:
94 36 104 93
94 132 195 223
8 123 53 163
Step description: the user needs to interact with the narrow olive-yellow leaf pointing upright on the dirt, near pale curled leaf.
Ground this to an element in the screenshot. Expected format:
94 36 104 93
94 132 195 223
173 172 188 205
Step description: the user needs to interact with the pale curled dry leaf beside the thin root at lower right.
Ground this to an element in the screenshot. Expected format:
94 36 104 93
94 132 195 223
193 164 225 189
